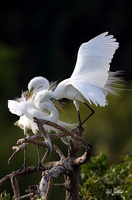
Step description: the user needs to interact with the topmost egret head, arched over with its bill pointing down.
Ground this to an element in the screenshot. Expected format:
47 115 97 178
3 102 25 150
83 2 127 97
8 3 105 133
27 76 49 99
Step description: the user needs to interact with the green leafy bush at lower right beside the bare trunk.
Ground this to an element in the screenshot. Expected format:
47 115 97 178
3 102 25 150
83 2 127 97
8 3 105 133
80 154 132 200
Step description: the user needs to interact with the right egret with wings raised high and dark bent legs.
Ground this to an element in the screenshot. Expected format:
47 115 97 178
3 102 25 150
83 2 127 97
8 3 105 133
29 32 119 127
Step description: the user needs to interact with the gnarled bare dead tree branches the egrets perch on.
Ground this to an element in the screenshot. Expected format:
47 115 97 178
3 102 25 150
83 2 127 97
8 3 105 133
0 118 92 200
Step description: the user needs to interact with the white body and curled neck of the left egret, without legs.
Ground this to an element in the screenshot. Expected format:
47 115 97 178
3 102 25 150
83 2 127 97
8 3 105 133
8 100 59 134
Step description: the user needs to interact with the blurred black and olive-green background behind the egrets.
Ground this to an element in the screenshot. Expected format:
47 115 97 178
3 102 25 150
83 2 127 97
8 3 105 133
0 0 132 199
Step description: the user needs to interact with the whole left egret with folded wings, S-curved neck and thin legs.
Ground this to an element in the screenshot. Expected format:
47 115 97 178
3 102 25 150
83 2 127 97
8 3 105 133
8 88 74 169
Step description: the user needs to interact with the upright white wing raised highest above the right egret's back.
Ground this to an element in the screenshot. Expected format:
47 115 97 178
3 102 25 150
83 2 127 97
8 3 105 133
71 32 119 87
